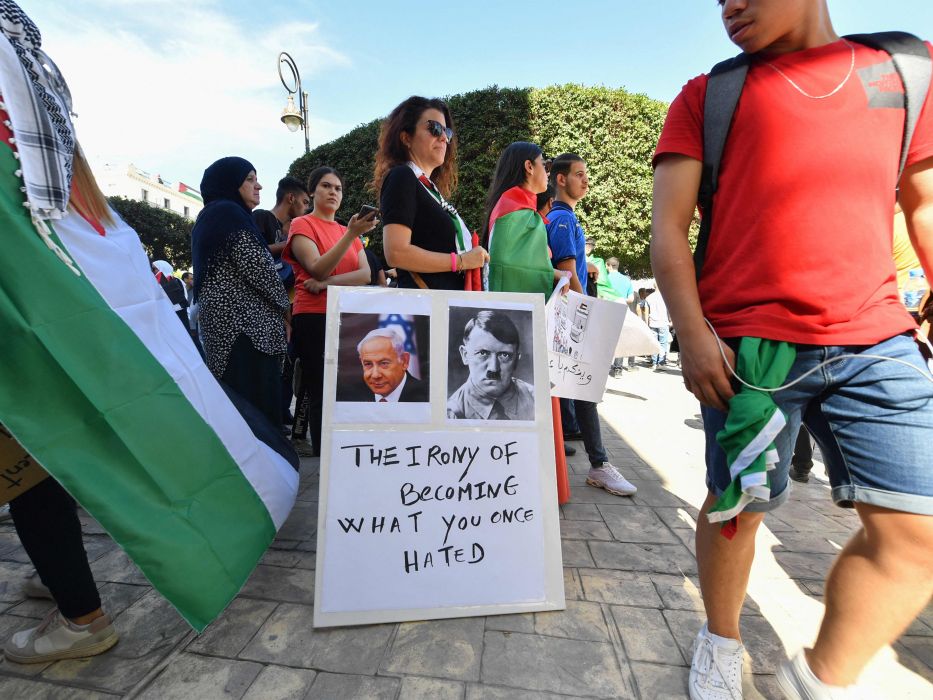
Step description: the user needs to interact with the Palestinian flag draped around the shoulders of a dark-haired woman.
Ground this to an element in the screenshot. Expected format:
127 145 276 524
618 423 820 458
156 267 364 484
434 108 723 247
486 187 554 295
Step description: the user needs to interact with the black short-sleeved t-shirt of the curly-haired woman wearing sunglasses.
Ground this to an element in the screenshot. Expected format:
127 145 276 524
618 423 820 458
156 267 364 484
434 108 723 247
379 165 464 289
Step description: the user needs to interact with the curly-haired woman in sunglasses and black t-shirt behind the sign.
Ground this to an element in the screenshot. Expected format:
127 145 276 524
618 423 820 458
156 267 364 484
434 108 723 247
373 97 489 289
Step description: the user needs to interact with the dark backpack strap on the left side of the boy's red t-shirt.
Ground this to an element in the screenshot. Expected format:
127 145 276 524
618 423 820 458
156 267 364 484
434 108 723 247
693 53 749 279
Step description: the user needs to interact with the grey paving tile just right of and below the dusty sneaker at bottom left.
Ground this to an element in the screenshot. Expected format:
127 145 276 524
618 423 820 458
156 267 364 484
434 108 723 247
42 591 190 693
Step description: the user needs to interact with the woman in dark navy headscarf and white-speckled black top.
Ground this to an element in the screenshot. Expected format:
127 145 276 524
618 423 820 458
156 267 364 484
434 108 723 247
191 156 289 427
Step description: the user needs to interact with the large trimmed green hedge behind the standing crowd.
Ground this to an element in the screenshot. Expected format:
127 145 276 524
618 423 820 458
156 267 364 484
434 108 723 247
289 85 667 276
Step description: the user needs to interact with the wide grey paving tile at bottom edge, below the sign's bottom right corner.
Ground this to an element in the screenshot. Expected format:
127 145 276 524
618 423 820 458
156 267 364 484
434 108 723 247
482 632 634 698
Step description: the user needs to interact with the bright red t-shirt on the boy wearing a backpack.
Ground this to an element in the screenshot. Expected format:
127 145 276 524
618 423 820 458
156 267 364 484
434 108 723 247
655 40 933 345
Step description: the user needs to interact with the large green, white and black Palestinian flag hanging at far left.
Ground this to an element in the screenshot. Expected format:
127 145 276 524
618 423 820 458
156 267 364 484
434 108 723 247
0 137 298 631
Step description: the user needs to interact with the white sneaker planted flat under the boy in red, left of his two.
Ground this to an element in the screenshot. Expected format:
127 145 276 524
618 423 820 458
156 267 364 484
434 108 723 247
688 624 745 700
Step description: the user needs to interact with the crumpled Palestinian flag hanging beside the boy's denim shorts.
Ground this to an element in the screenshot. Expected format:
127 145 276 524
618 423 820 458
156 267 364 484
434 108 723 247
708 337 797 536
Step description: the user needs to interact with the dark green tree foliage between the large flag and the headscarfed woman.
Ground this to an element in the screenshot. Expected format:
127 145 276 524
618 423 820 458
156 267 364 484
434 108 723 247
107 197 194 269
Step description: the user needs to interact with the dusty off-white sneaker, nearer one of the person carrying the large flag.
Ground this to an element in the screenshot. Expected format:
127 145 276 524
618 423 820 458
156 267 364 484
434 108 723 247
3 608 117 664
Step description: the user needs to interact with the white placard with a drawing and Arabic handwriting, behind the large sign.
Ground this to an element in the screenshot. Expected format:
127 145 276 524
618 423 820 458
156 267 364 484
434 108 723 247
547 291 628 403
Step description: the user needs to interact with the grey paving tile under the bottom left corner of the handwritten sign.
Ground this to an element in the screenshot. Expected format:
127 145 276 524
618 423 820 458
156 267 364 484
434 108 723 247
239 603 392 674
